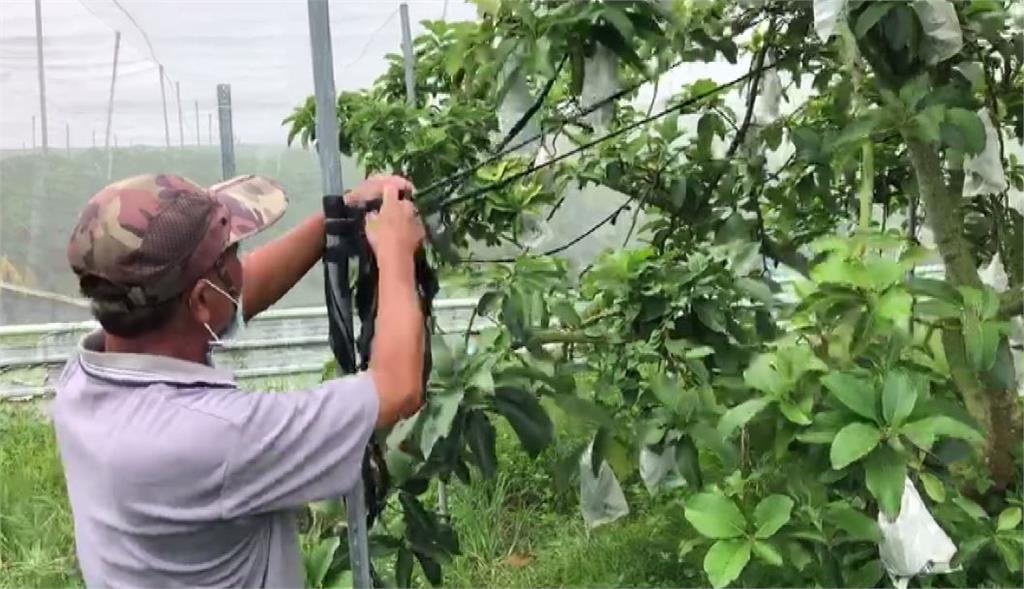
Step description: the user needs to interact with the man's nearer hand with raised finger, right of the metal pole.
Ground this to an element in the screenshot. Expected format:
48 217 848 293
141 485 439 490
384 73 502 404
367 181 426 260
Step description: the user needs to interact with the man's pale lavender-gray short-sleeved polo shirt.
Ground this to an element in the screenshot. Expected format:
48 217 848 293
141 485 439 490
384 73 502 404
53 332 378 588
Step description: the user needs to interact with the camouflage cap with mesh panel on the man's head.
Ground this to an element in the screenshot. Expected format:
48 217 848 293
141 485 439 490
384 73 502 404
68 174 288 306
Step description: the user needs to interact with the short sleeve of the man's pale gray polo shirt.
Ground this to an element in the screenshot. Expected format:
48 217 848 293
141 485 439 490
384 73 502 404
221 373 380 517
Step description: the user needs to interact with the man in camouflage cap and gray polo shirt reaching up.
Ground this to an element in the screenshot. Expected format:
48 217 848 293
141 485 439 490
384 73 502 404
53 175 424 587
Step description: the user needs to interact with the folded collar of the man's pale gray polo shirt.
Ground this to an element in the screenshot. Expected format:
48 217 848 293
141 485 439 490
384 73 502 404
78 329 236 386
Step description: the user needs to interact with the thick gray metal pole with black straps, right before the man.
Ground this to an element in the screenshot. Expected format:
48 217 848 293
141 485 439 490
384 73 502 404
306 0 373 589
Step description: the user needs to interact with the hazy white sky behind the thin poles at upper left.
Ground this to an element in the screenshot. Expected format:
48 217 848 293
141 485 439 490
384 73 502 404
0 0 476 149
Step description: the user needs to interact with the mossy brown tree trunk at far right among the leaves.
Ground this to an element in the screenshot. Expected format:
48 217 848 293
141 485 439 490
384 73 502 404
904 134 1022 490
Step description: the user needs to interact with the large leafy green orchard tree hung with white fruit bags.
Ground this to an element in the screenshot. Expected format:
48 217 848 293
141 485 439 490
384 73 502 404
286 0 1024 587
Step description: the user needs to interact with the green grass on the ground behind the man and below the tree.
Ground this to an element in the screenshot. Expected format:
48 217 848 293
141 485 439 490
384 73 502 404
0 404 699 588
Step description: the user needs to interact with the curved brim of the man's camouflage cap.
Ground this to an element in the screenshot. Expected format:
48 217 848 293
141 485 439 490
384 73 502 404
209 175 288 246
